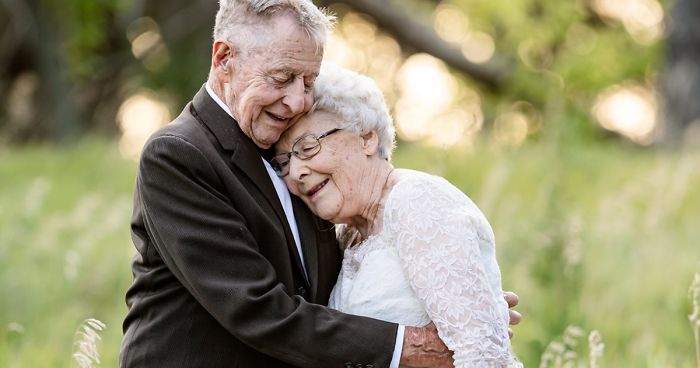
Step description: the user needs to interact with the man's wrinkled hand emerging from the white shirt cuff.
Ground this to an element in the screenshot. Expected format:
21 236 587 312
399 324 454 368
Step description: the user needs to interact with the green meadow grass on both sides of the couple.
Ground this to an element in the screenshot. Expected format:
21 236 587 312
0 138 700 368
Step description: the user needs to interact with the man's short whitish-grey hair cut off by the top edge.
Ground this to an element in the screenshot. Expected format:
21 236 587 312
213 0 335 52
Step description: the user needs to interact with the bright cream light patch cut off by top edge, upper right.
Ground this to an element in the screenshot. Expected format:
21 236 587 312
591 0 664 45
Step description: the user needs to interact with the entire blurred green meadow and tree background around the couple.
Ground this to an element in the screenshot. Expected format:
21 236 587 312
0 0 700 367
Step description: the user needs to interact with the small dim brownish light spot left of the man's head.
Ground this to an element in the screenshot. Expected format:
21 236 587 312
126 17 170 71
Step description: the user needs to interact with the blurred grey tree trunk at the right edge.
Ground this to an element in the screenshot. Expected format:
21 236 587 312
662 0 700 143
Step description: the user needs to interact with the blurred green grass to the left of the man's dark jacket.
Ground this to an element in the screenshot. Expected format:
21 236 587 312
0 142 134 367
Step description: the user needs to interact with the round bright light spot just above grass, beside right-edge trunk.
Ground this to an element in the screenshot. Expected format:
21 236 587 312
593 84 657 144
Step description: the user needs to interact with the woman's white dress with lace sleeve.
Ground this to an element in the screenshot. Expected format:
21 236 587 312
329 170 522 368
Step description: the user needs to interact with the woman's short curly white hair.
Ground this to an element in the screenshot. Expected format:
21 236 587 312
309 62 396 161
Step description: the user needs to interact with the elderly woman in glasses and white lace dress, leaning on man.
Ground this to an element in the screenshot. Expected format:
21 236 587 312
271 65 521 368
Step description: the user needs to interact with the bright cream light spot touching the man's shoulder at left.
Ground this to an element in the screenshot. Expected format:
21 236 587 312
117 92 171 160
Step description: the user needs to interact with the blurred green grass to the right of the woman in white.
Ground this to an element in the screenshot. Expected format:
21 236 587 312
396 137 700 367
